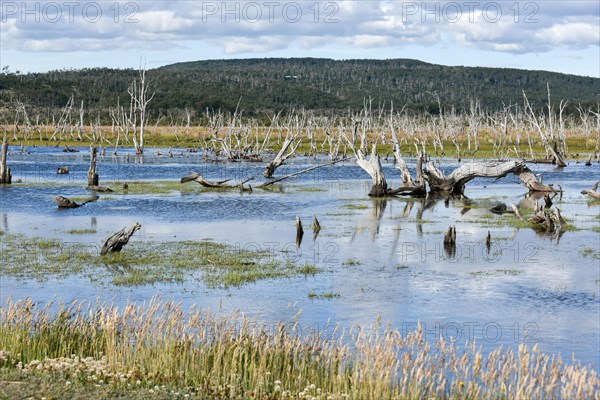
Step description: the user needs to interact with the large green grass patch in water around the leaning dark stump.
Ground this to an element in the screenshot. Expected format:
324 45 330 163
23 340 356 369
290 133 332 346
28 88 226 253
3 235 319 288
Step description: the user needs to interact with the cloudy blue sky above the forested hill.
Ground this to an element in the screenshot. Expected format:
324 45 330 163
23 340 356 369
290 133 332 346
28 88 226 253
0 0 600 77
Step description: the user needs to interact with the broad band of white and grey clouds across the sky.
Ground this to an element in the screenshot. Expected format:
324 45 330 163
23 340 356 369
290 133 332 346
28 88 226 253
0 0 600 62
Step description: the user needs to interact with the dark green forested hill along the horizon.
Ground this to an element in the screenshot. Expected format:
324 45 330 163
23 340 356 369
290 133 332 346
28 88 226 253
0 58 600 116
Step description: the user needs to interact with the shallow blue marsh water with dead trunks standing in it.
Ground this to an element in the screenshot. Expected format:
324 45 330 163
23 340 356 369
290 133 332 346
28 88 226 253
0 147 600 368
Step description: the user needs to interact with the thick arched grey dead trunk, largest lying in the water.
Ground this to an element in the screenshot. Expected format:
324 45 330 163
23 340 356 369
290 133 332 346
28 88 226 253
423 161 557 194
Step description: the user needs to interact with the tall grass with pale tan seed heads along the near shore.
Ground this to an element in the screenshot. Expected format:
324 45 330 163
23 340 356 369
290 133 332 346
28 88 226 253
0 298 600 399
